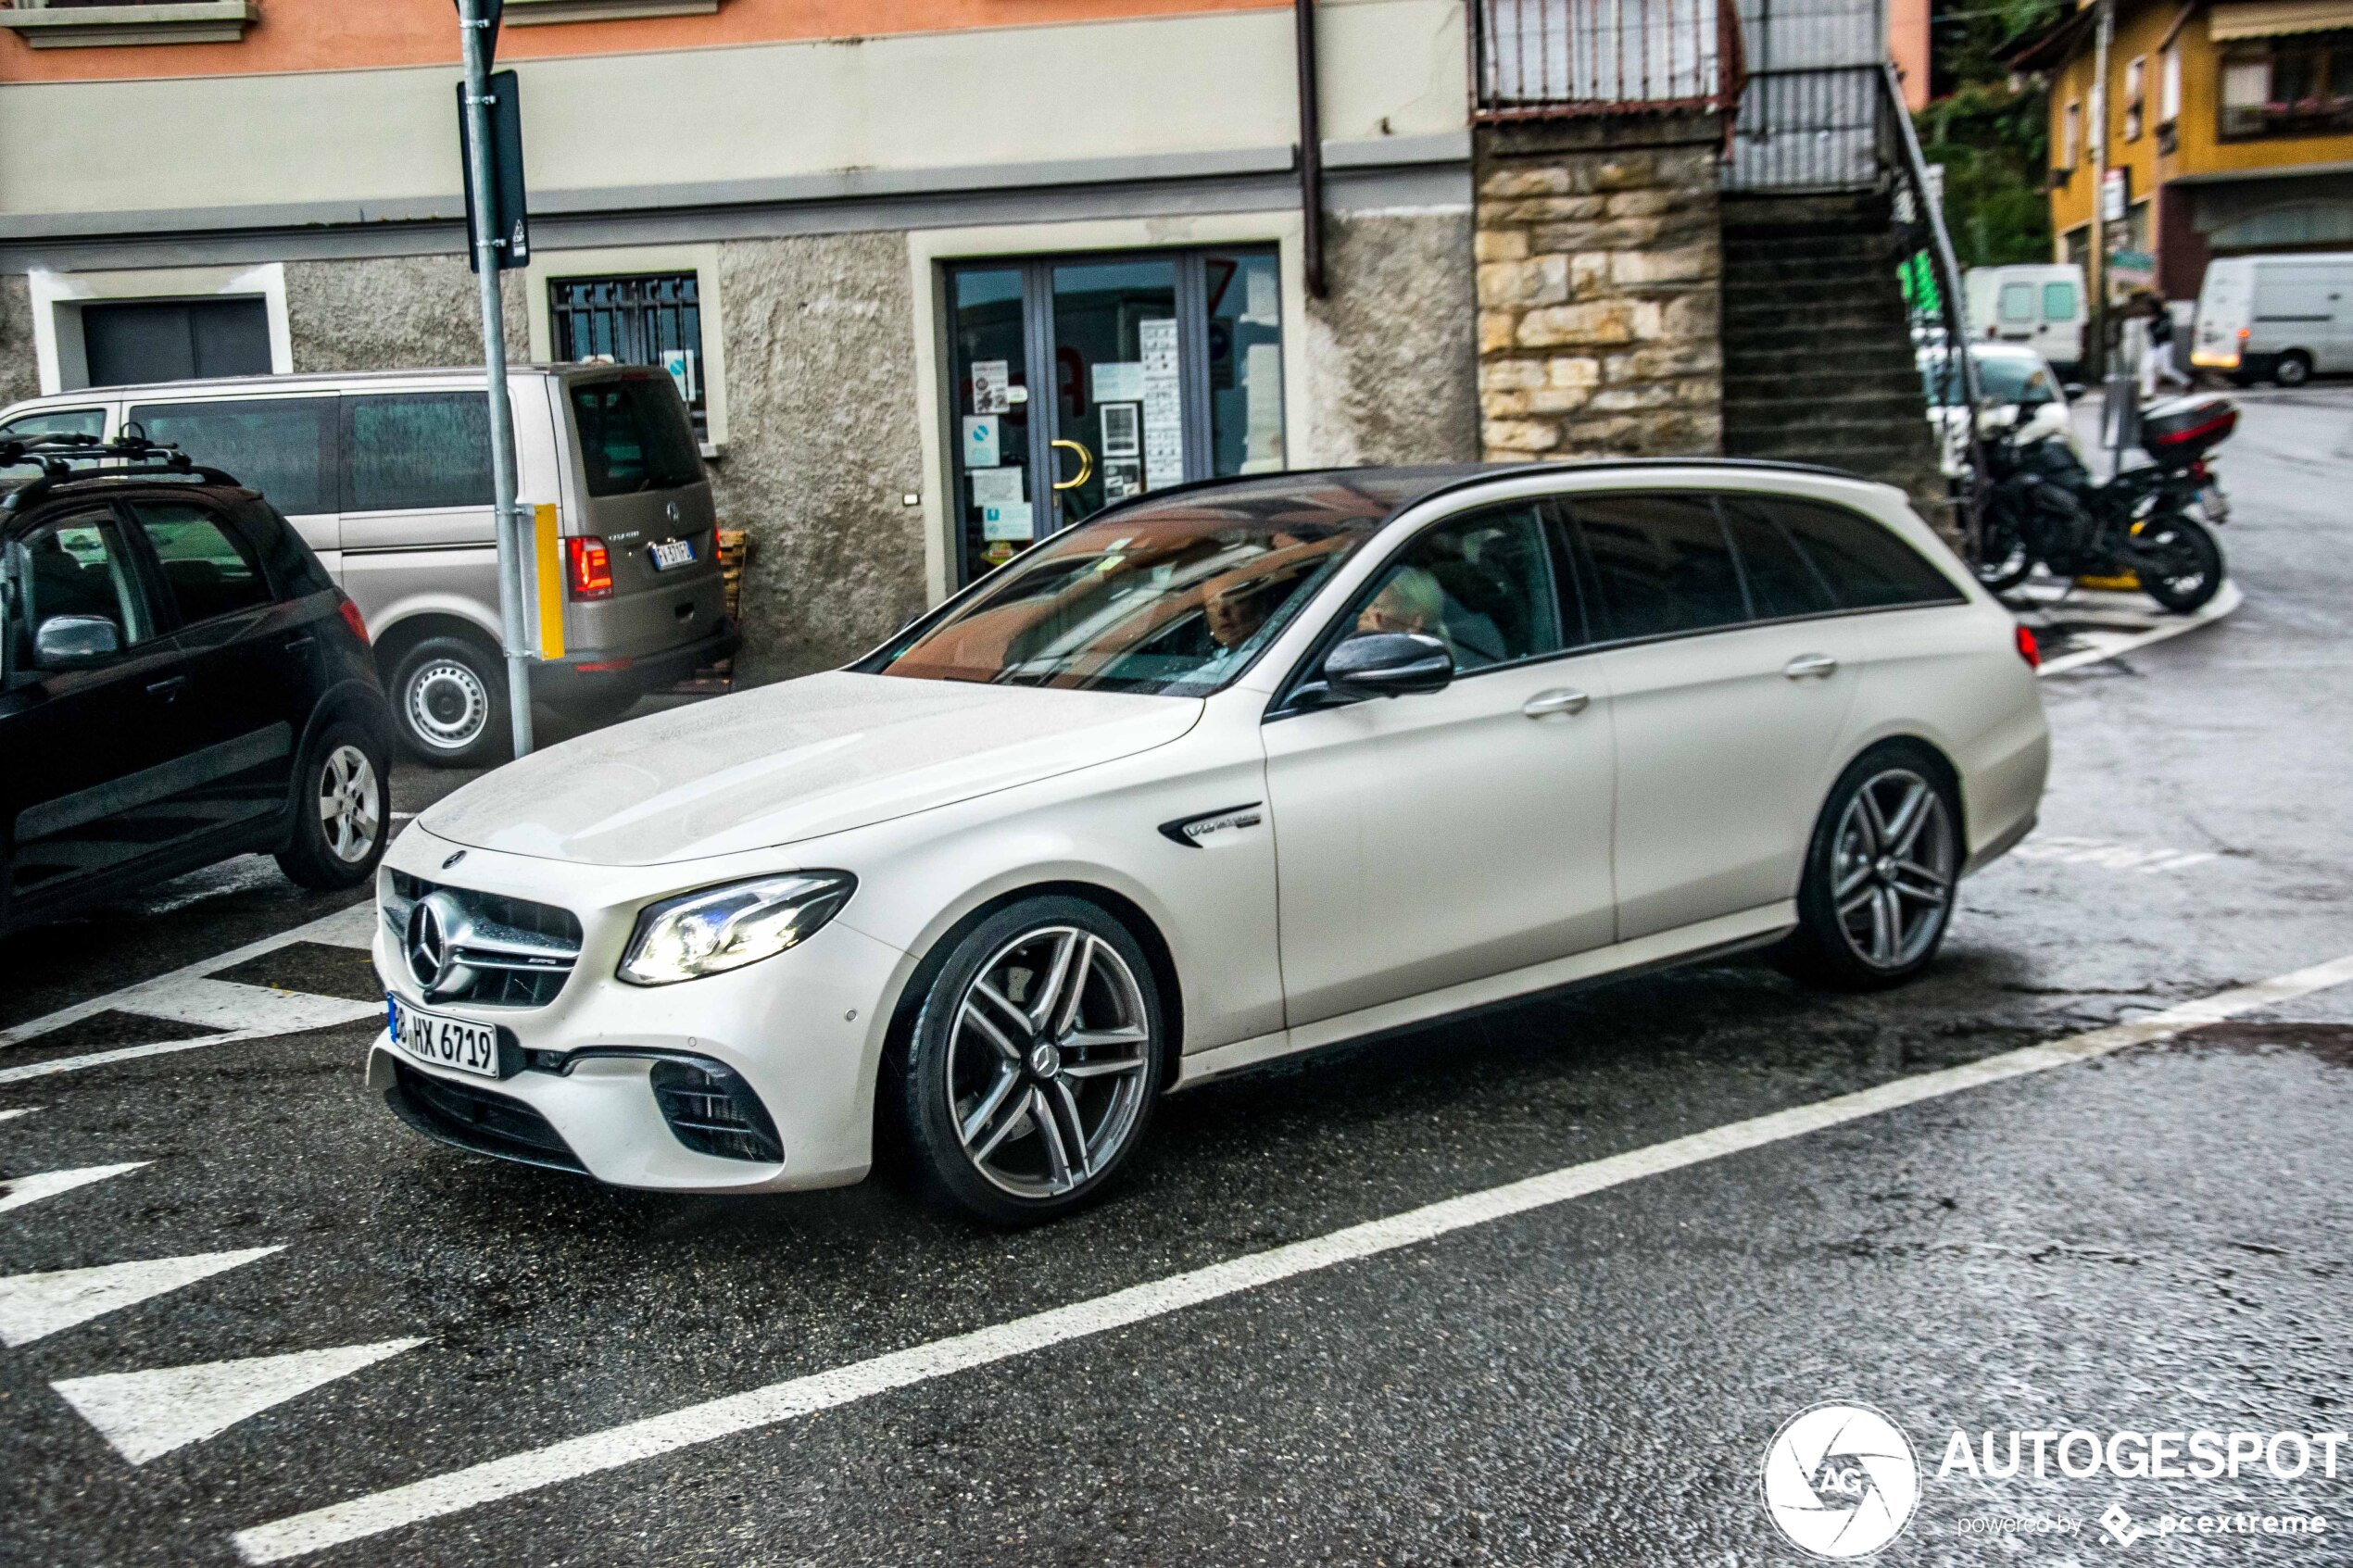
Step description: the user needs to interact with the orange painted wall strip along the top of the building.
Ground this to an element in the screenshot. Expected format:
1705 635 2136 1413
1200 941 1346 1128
0 0 1285 82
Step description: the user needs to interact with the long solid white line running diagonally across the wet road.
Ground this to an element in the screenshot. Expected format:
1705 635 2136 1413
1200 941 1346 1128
235 957 2353 1563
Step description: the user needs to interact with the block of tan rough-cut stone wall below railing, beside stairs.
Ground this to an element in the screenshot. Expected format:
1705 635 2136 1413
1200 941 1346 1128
1473 115 1722 460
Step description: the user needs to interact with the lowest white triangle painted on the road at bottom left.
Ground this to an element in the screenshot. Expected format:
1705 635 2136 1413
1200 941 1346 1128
49 1340 423 1464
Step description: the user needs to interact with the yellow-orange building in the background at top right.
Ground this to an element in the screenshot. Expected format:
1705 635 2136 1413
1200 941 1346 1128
2009 0 2353 298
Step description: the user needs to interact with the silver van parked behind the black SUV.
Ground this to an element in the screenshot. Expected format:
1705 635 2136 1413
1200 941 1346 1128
0 364 736 766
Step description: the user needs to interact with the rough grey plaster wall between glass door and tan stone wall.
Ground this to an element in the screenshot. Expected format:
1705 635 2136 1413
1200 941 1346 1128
1291 211 1478 466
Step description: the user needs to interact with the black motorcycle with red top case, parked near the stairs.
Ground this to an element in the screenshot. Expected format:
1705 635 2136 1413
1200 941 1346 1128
1977 397 2238 613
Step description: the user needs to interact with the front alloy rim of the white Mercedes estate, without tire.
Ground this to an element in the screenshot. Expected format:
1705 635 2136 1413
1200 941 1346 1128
946 924 1155 1198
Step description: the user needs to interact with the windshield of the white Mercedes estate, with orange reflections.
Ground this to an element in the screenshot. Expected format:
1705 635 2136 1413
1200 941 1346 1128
859 475 1395 696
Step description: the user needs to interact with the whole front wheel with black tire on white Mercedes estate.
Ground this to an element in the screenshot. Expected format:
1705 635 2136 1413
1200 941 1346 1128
885 896 1167 1227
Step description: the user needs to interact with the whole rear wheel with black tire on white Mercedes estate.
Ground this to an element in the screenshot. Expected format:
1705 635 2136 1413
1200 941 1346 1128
1774 741 1965 990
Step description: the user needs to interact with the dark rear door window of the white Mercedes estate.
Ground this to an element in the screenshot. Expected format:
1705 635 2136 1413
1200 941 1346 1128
1567 494 1748 642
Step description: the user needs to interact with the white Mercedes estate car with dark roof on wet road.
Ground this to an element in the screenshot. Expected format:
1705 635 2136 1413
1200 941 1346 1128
367 460 2049 1224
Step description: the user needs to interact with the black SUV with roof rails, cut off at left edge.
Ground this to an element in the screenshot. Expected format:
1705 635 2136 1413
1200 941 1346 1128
0 435 393 931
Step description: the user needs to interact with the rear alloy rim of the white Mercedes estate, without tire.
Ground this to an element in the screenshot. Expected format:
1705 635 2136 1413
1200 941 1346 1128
1831 769 1957 971
